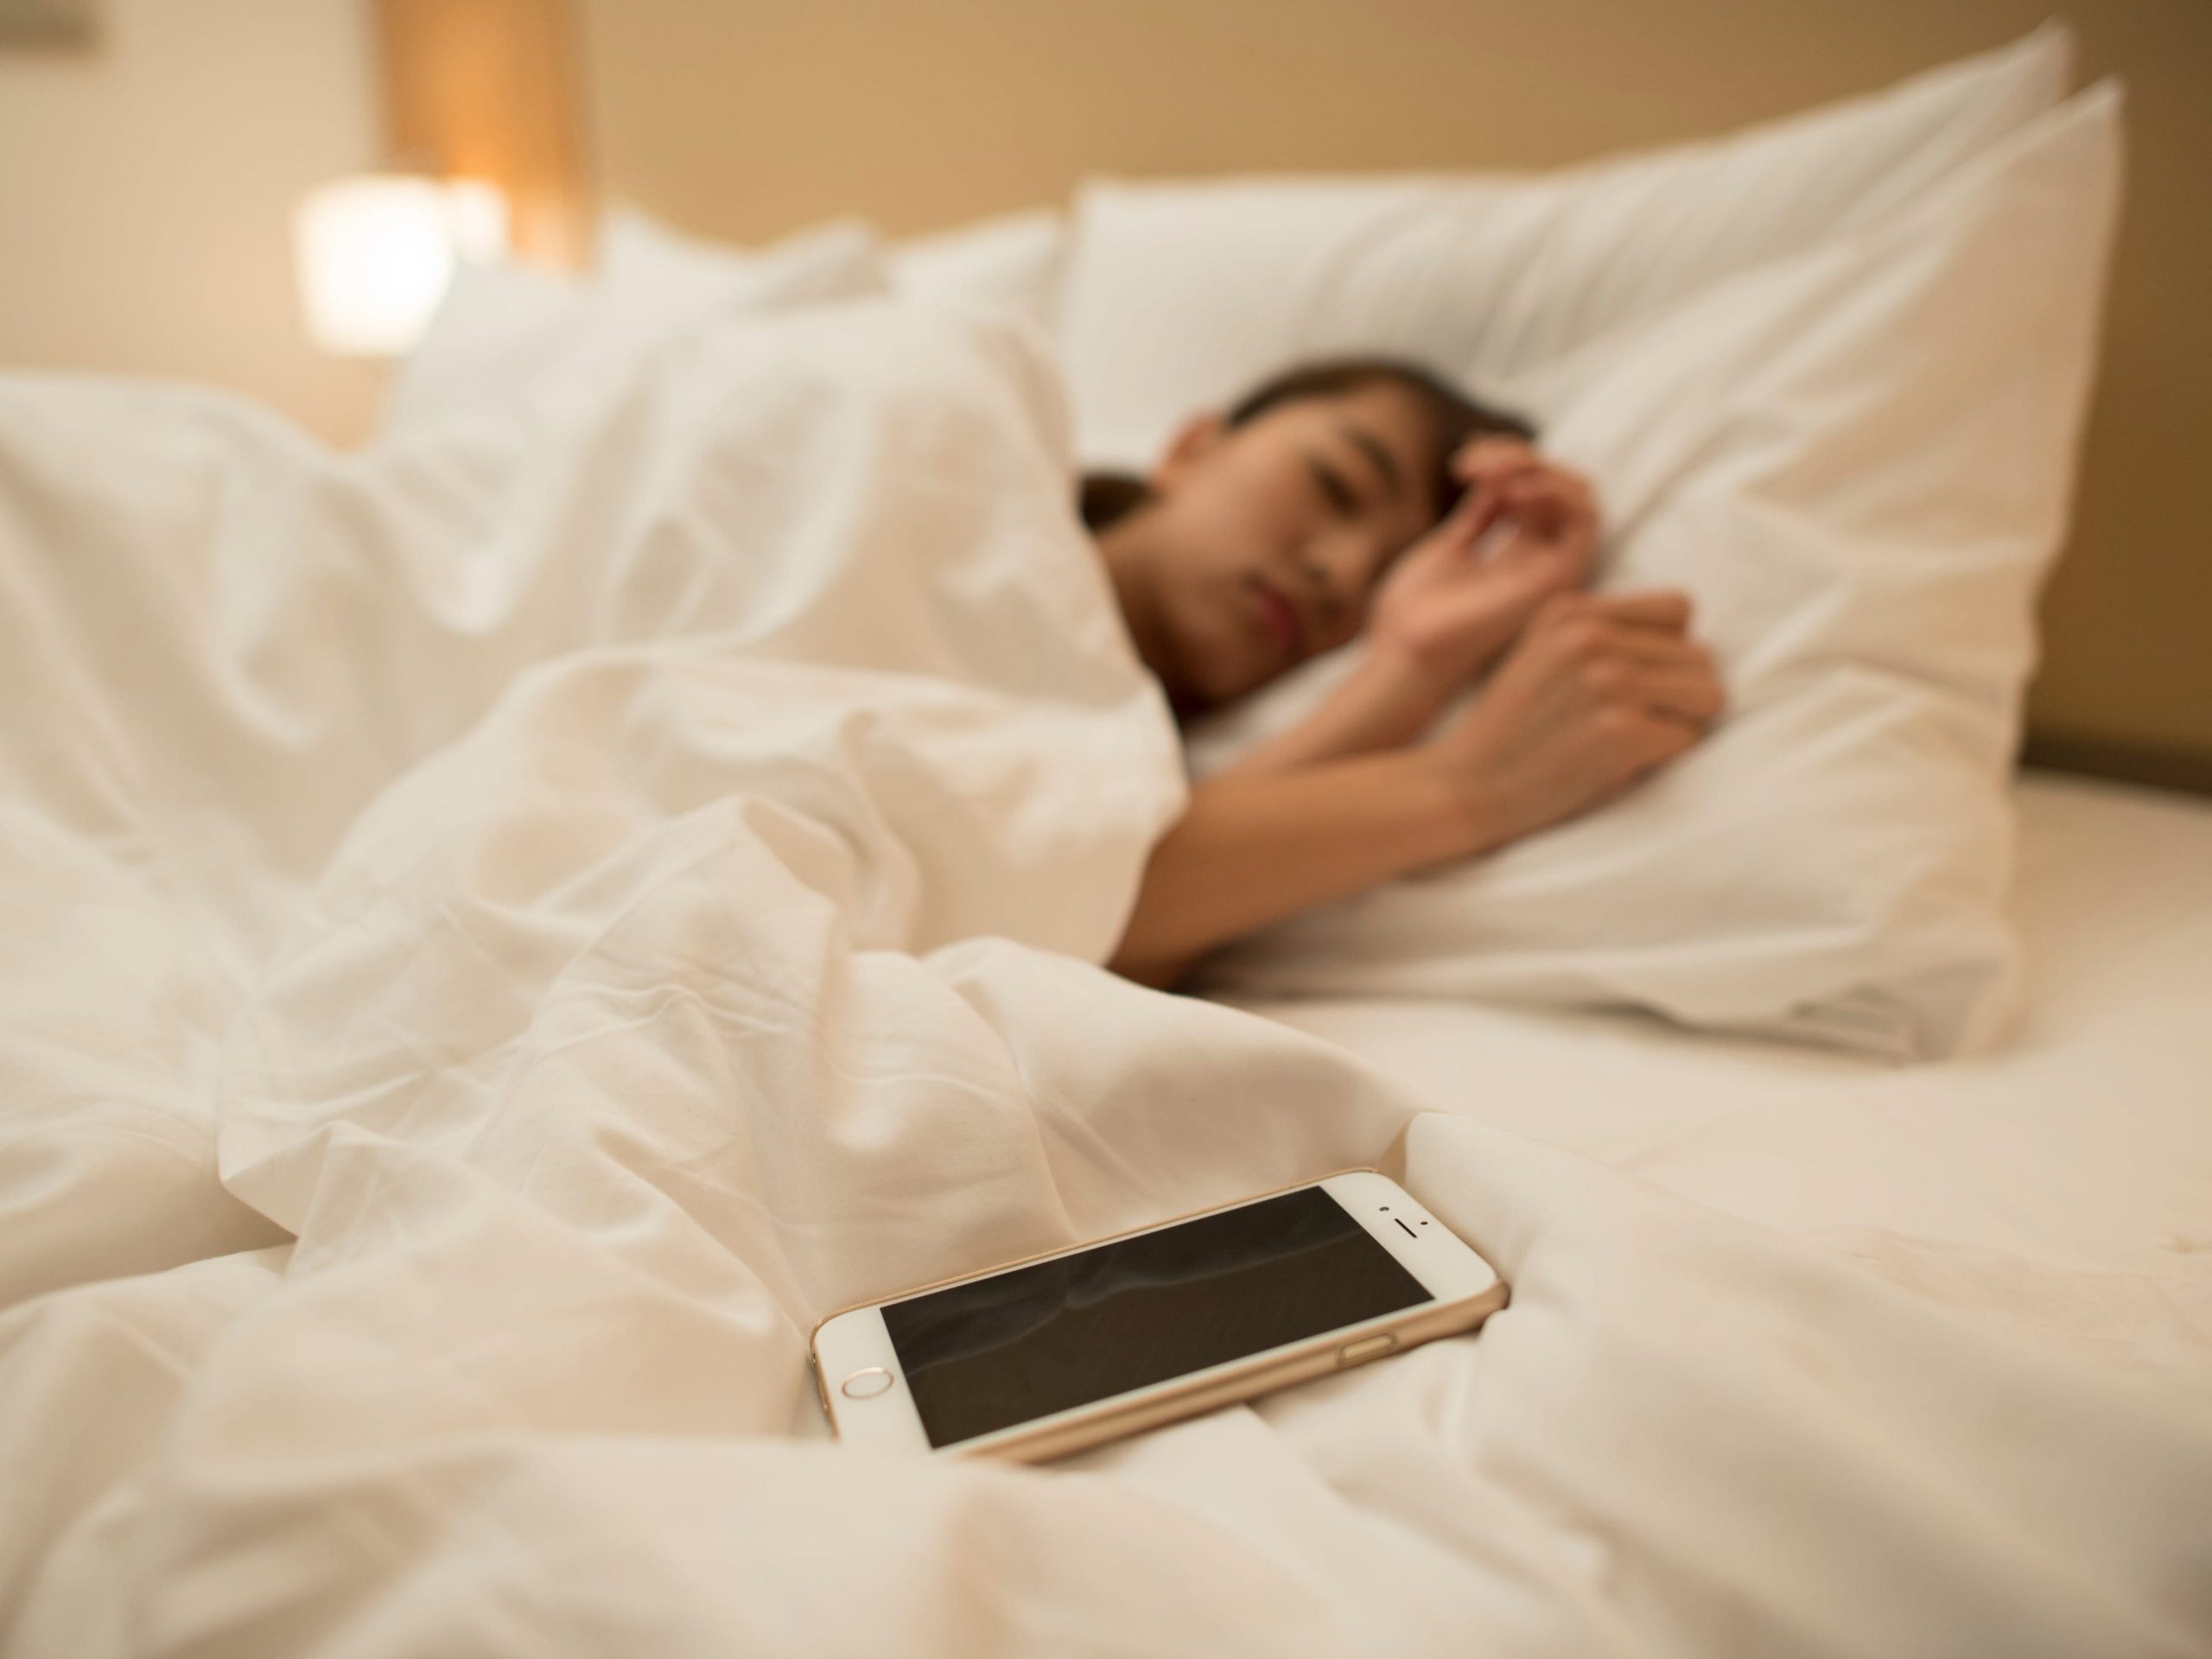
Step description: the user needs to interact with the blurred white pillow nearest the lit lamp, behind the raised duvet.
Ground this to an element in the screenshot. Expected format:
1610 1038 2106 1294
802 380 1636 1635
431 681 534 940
380 206 887 440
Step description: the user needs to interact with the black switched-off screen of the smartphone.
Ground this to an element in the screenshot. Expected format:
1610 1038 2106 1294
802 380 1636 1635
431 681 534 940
882 1188 1433 1446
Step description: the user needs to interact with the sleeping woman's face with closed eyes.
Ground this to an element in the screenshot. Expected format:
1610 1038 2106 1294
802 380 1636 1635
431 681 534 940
1130 380 1438 706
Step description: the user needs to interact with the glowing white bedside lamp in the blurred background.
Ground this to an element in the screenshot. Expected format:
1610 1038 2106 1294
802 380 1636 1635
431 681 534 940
292 175 506 356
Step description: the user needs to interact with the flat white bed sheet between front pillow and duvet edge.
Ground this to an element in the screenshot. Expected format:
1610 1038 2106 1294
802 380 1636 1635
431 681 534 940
1239 774 2212 1367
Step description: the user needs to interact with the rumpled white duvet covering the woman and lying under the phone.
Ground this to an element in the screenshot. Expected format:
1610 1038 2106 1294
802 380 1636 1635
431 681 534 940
0 305 2212 1656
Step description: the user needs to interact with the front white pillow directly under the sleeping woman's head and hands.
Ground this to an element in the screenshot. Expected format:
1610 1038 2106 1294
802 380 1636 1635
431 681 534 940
1176 84 2121 1058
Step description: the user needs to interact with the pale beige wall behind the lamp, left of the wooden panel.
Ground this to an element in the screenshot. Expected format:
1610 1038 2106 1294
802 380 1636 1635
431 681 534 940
0 0 380 440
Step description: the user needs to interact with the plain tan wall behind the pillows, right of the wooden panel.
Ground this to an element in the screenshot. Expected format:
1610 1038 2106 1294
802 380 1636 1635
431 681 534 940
580 0 2212 774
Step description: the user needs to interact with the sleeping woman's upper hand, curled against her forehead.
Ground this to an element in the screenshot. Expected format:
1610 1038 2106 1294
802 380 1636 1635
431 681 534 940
1367 435 1597 688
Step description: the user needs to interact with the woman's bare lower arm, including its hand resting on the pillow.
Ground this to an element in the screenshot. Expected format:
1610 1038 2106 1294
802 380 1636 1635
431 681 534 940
1110 593 1721 988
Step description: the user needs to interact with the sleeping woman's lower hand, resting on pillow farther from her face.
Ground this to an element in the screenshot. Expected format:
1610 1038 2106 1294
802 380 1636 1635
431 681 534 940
1422 593 1726 852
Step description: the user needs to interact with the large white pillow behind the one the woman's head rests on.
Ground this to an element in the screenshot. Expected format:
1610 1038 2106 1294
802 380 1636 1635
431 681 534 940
1062 24 2073 471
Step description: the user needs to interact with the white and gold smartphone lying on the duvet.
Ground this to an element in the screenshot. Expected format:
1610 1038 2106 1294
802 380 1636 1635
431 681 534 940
810 1170 1506 1462
